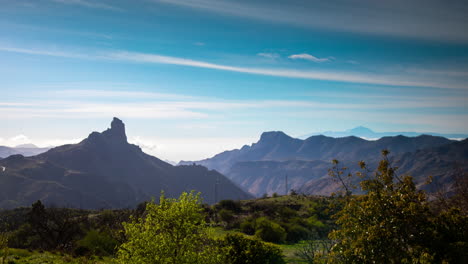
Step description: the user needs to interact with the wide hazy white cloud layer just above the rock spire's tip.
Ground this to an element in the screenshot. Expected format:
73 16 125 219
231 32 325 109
0 90 465 120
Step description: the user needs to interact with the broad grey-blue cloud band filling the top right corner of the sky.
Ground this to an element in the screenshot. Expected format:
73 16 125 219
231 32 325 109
153 0 468 42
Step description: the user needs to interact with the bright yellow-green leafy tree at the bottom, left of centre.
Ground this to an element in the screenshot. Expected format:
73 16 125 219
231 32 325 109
117 192 218 264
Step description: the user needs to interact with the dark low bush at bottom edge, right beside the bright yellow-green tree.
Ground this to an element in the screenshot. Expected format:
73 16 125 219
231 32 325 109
221 234 285 264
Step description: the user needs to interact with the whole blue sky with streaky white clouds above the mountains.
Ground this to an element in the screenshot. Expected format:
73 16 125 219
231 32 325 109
0 0 468 160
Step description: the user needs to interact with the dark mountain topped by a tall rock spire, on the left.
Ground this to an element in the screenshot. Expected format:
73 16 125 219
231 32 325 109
0 118 251 208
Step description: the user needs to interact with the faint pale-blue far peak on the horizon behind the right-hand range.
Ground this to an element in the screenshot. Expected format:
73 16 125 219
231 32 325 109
299 126 468 139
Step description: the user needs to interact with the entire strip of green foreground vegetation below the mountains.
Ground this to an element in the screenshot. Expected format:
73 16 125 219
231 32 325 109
0 152 468 263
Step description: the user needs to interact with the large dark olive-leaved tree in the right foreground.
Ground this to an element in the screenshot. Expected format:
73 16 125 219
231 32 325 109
330 151 468 263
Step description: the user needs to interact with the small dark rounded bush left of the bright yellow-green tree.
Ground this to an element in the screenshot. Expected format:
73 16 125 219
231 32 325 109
75 230 119 256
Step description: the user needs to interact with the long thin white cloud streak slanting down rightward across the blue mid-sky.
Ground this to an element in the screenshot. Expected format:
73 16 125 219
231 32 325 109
0 46 468 89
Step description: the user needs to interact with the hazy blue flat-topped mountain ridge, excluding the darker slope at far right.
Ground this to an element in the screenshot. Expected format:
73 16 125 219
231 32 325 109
180 131 453 196
